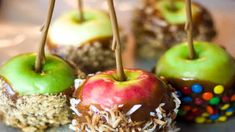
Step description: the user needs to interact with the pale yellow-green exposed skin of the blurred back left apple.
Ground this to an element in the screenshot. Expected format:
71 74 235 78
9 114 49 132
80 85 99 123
48 9 113 46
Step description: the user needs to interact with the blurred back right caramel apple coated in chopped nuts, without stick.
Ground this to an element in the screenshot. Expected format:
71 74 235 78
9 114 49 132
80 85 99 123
132 0 216 58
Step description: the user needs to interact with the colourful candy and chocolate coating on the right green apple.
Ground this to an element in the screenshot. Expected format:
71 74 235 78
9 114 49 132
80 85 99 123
177 83 235 123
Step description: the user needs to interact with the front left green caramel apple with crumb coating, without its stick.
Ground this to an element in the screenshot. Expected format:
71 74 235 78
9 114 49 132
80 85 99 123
0 53 79 132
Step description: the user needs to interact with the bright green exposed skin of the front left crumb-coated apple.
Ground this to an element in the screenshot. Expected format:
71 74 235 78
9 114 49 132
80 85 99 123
0 53 75 96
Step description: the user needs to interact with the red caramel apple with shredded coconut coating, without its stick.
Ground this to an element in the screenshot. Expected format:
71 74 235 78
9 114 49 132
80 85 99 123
70 69 180 132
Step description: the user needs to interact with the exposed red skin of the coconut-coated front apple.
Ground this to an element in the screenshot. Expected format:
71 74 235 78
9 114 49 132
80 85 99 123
77 69 165 110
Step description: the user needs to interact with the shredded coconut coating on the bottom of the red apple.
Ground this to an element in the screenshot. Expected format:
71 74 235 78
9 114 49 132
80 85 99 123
70 80 181 132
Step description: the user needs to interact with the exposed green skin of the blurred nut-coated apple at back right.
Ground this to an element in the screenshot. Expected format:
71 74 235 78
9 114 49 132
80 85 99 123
156 0 201 24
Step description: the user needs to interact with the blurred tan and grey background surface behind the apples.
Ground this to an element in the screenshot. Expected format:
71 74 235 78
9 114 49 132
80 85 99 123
0 0 235 132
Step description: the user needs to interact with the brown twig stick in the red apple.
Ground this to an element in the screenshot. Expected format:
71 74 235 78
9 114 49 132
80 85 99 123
107 0 126 81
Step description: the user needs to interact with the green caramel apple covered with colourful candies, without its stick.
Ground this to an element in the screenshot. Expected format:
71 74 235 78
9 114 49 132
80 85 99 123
156 42 235 123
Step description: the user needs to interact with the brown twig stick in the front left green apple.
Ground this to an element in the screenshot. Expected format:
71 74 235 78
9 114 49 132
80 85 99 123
35 0 56 72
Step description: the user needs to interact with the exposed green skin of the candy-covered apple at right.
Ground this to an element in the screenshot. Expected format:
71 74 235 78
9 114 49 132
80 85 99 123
155 42 235 85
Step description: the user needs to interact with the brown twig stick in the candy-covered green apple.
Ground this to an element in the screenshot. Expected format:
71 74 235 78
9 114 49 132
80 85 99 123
185 0 196 59
